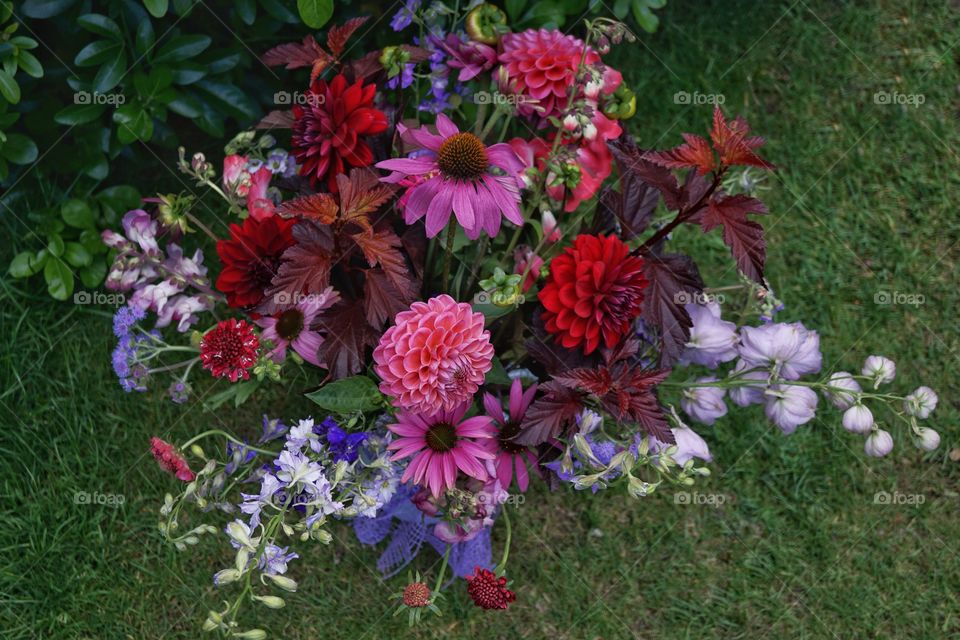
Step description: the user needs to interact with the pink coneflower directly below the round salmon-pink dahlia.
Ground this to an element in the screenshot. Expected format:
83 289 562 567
387 402 494 497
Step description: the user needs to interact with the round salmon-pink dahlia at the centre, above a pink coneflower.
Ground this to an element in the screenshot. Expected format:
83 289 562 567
373 294 493 414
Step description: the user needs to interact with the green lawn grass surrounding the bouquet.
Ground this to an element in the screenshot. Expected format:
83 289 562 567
0 0 960 640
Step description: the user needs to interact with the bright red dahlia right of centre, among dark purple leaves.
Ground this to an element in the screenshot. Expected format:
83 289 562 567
537 235 647 354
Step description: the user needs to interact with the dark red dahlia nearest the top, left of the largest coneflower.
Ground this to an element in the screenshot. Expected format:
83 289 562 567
291 74 387 193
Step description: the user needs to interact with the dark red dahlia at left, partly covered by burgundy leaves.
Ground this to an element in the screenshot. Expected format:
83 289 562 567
217 216 294 307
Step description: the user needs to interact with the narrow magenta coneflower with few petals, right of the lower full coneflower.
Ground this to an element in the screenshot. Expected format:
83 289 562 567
483 380 537 491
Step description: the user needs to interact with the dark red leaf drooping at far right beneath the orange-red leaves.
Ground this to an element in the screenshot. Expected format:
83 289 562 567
700 194 767 284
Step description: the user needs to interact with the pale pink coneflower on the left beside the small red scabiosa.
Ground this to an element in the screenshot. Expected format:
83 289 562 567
254 287 340 367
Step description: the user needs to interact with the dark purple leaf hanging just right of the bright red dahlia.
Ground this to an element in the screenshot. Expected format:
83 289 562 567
643 252 703 366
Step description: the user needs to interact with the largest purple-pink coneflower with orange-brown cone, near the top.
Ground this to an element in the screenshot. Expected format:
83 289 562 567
377 113 523 238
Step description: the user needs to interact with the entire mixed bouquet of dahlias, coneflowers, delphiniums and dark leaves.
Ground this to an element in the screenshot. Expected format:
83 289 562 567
104 2 939 638
